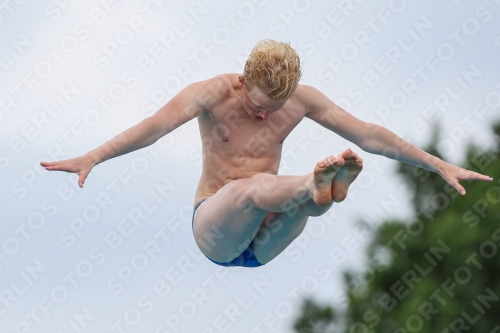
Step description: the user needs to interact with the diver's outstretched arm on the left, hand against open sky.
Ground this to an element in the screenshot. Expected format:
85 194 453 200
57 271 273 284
40 78 222 187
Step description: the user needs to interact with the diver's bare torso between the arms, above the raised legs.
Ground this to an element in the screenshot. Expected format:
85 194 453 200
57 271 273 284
195 74 306 205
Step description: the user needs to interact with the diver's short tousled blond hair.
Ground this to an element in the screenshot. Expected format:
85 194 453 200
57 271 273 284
243 39 302 99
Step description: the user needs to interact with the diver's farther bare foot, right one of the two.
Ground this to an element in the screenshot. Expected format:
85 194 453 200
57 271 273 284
332 149 363 202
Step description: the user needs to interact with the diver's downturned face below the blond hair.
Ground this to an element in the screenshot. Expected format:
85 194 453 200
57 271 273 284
241 81 286 121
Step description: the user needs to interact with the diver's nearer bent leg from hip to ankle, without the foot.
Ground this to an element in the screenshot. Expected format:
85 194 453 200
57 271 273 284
194 174 311 262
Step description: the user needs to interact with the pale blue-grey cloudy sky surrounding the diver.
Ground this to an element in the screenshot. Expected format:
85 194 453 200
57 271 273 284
0 0 500 333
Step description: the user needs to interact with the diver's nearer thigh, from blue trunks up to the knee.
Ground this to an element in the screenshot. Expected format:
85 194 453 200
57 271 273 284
193 179 268 262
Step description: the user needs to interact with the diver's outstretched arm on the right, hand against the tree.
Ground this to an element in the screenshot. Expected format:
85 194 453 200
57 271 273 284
301 86 492 195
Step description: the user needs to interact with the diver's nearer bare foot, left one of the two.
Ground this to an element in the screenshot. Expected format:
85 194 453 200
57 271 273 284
313 156 344 206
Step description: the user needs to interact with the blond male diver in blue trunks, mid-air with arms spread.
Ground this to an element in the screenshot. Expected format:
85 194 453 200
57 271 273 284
41 40 492 267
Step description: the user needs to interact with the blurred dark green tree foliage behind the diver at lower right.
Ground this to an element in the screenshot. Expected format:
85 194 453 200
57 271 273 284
294 124 500 333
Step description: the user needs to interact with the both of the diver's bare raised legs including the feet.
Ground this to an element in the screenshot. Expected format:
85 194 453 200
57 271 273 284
194 149 362 263
